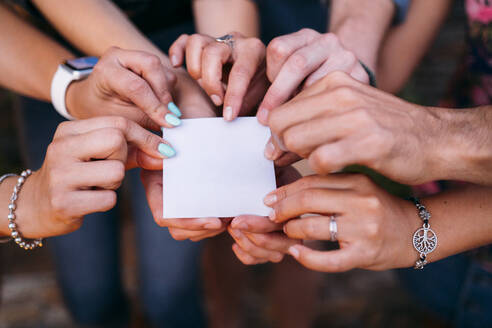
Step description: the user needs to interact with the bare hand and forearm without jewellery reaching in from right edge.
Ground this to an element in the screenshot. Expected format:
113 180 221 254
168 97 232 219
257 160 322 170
268 72 492 185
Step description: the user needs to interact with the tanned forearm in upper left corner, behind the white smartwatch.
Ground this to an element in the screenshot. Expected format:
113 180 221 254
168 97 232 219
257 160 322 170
0 5 73 101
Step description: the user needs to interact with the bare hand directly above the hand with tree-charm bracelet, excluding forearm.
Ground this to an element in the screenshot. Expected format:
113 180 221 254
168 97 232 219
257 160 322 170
268 72 449 184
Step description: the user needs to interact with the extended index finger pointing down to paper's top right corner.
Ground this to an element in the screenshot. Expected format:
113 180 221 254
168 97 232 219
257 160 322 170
261 40 330 108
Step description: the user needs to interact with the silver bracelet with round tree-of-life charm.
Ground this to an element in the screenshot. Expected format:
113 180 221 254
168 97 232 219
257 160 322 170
409 197 437 270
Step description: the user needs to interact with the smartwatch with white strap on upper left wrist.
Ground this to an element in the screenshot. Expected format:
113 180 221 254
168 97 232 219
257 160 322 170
51 57 98 120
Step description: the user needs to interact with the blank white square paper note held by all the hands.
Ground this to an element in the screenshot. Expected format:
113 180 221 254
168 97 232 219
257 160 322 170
162 117 276 218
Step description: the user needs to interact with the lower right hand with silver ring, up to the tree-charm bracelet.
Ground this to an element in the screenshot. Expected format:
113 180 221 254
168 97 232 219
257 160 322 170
268 174 422 272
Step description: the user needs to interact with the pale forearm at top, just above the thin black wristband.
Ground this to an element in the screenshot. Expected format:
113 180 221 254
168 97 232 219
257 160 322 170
329 0 395 75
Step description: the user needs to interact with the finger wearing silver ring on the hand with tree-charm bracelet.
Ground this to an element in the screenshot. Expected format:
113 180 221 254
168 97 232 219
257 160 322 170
284 216 350 240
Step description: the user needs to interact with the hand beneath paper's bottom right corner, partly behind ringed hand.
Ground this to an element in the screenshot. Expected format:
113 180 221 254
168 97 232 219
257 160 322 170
228 167 301 265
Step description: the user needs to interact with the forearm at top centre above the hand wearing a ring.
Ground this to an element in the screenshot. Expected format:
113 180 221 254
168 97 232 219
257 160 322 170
193 0 260 37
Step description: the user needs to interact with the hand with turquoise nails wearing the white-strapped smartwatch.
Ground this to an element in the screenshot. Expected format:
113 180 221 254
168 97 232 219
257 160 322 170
66 47 181 130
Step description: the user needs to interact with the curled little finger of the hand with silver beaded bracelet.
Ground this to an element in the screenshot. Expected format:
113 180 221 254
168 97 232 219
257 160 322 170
63 190 116 218
